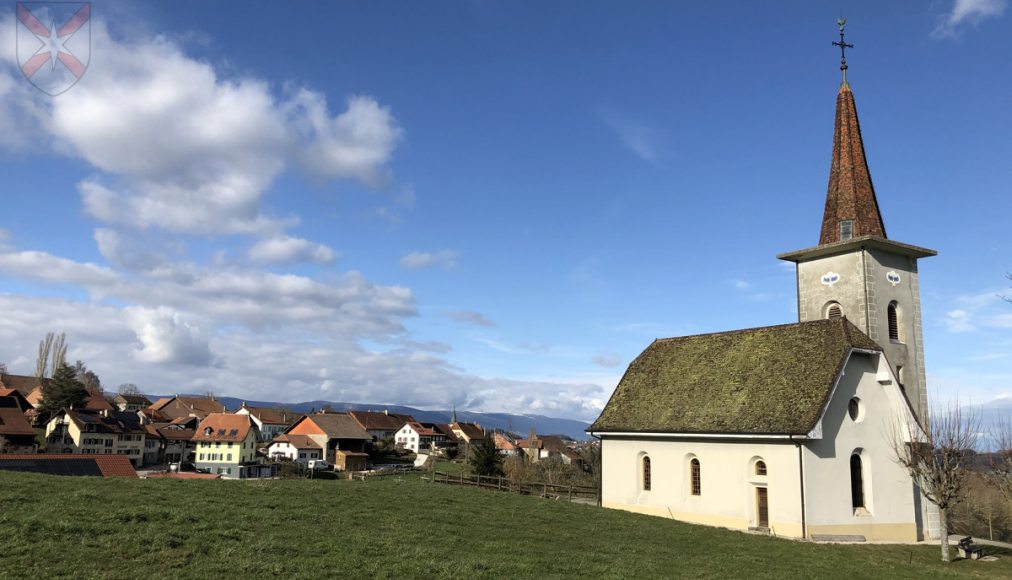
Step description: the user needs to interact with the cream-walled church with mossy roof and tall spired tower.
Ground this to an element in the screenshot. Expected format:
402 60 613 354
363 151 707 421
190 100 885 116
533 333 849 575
588 25 937 542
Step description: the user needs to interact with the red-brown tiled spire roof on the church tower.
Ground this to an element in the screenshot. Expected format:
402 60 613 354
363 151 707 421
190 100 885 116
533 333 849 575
819 81 887 246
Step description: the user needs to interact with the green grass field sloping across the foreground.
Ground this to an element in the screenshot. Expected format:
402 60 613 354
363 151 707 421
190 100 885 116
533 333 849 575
0 472 1012 580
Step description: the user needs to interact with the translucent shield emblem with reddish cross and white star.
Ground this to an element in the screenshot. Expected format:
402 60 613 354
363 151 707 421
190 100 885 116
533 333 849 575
16 2 91 96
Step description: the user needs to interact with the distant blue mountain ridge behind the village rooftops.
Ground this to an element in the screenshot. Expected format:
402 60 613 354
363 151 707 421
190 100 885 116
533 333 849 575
184 397 590 439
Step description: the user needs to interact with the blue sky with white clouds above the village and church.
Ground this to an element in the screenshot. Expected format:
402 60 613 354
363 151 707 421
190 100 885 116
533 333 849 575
0 0 1012 419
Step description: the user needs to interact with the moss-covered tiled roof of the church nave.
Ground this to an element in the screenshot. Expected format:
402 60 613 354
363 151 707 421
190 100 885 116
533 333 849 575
588 319 881 434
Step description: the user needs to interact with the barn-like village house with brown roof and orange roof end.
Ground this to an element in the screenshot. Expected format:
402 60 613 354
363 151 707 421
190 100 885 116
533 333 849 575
284 413 372 471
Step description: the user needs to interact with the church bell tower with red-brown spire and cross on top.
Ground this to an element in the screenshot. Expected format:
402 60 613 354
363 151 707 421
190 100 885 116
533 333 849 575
777 21 937 424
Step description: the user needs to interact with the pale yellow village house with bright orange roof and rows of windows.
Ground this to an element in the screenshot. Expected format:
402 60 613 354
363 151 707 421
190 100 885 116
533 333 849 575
192 413 261 479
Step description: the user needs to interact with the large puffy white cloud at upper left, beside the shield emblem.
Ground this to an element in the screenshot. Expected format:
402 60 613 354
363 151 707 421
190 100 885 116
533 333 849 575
0 17 403 235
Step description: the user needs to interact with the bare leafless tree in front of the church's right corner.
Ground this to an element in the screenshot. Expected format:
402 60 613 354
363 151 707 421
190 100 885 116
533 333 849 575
894 402 981 562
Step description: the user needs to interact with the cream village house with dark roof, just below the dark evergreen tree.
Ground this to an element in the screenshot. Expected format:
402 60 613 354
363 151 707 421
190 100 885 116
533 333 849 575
46 409 147 467
